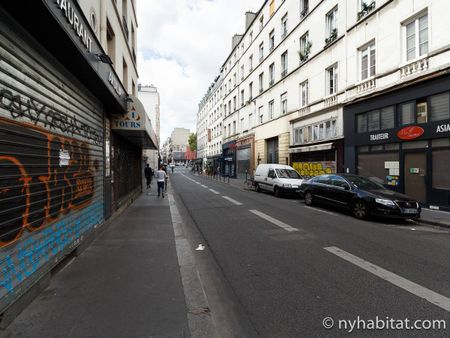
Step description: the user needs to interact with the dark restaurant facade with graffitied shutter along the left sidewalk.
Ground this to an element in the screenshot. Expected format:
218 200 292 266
0 0 154 325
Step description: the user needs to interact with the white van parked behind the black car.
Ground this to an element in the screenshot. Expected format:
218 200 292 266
254 164 303 197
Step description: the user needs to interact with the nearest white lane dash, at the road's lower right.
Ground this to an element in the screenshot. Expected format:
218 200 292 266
324 246 450 312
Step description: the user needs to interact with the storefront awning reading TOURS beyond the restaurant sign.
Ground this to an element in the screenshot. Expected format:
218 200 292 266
111 96 158 149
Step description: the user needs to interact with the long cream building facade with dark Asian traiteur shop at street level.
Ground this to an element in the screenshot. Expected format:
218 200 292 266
198 0 450 209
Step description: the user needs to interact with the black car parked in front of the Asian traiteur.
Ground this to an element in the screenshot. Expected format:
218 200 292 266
300 174 421 219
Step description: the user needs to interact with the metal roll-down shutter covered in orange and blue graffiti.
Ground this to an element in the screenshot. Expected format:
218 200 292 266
0 15 103 311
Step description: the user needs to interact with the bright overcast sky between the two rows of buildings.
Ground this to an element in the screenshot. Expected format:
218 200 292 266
137 0 263 142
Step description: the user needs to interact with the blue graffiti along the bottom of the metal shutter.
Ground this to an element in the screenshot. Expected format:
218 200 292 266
0 202 103 298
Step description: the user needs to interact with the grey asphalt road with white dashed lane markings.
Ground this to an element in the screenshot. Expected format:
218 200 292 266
170 168 450 337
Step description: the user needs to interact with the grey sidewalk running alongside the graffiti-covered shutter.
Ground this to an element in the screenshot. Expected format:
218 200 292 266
1 184 190 338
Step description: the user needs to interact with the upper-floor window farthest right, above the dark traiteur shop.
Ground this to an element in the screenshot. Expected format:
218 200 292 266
404 13 428 61
